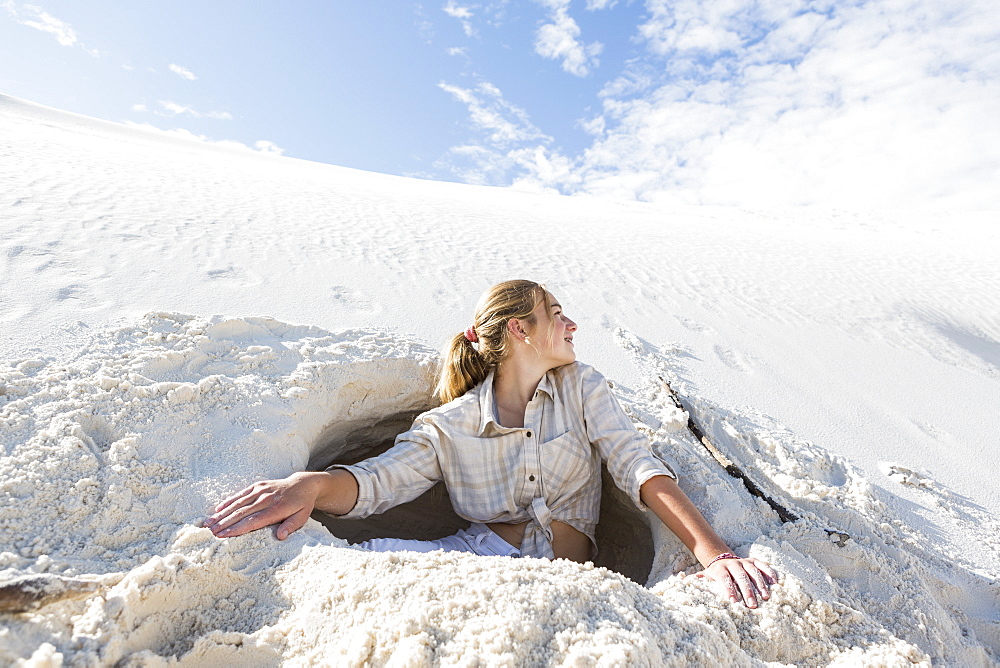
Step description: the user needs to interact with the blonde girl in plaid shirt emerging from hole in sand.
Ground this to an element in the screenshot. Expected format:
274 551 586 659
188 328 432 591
205 280 777 608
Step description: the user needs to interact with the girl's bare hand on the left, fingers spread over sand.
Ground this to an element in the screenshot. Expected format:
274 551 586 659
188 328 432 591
202 472 329 540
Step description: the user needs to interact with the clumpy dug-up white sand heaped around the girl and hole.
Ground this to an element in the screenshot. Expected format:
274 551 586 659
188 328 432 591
0 313 1000 666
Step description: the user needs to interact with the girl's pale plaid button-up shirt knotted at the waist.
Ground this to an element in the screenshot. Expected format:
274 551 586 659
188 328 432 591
331 362 676 558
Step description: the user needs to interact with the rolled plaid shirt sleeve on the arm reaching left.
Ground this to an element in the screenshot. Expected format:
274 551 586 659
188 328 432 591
327 416 443 519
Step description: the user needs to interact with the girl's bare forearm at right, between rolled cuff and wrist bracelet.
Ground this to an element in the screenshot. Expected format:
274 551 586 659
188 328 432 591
639 475 731 566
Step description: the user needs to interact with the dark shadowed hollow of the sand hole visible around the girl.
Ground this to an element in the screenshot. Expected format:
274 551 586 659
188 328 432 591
309 413 653 584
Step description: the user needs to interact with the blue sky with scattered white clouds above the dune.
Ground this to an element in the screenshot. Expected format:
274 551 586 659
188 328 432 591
0 0 1000 209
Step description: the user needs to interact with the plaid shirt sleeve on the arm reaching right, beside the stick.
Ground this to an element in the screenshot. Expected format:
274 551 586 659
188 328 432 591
581 367 677 510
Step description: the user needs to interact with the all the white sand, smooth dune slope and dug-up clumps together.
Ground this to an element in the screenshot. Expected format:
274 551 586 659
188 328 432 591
0 97 1000 666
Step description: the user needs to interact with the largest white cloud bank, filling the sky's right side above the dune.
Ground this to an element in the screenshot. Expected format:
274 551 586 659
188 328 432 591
466 0 1000 209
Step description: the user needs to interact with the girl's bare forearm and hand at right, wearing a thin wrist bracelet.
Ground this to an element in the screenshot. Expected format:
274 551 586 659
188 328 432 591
639 475 778 608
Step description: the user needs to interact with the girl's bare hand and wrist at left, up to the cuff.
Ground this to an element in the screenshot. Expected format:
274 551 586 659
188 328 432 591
203 469 358 540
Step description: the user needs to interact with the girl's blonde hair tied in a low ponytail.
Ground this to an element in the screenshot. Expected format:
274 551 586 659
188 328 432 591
434 280 547 404
